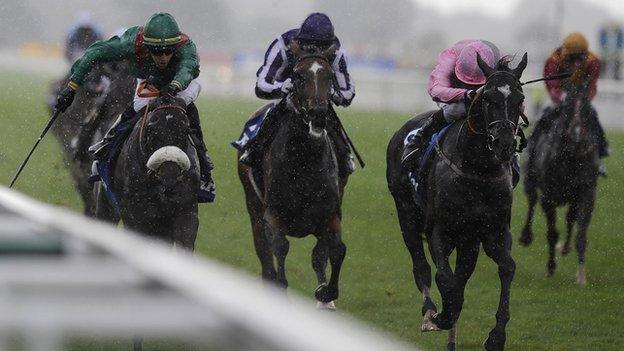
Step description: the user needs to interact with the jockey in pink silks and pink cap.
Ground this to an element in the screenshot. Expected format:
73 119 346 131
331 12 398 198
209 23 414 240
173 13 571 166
401 40 501 170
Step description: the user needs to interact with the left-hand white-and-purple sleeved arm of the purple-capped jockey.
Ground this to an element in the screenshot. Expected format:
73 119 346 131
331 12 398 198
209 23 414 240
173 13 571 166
255 36 288 100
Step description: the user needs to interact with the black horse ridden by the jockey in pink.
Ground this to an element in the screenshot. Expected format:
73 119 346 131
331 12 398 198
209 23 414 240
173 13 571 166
386 54 527 350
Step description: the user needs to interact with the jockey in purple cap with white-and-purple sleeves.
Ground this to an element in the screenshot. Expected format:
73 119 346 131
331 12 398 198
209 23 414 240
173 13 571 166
240 13 355 176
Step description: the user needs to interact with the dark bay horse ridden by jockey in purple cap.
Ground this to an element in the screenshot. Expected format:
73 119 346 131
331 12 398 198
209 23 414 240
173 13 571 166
238 44 347 309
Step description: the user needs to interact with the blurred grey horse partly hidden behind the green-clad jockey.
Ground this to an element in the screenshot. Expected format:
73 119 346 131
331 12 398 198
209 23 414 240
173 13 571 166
51 64 135 217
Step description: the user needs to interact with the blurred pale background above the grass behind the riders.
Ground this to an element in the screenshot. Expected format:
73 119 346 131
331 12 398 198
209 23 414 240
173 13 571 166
0 0 624 126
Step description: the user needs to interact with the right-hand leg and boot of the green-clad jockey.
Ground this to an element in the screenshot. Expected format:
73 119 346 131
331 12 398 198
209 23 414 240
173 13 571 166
186 102 216 202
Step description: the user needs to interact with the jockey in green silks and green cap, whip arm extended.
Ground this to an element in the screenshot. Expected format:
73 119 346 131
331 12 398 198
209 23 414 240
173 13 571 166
56 13 215 202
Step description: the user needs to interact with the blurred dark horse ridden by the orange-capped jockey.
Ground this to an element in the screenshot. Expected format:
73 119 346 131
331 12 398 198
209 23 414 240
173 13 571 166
519 90 599 285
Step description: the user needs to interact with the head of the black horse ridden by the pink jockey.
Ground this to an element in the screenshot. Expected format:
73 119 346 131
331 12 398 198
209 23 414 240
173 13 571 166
476 53 527 162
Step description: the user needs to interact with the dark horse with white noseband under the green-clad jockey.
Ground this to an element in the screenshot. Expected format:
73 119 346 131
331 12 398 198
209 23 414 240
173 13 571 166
95 98 199 251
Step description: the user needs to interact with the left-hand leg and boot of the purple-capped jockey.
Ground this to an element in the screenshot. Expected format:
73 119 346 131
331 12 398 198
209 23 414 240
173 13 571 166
238 104 281 168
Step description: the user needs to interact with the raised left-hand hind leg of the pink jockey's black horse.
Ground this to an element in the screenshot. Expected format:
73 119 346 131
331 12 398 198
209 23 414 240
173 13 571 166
392 194 437 319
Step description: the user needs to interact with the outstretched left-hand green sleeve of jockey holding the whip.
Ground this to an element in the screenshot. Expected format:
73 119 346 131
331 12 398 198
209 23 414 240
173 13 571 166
69 27 137 89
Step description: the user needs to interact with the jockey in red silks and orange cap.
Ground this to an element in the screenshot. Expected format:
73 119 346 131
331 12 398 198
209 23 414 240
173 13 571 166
533 32 609 175
